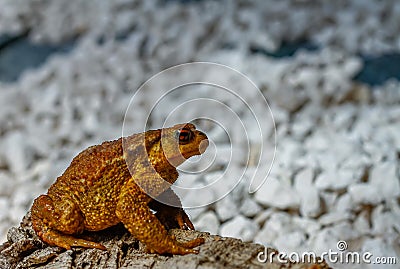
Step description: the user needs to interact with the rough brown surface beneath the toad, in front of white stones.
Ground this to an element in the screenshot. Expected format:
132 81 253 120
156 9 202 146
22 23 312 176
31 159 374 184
0 213 329 269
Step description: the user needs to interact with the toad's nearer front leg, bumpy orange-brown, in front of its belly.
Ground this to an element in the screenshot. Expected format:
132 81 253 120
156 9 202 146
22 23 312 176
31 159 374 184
116 180 204 255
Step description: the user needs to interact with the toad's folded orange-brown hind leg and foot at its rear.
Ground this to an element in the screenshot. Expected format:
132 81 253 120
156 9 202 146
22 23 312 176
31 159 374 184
31 195 106 250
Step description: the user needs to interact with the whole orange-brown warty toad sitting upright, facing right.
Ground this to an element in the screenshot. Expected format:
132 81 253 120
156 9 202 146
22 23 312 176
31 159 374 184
31 123 208 254
